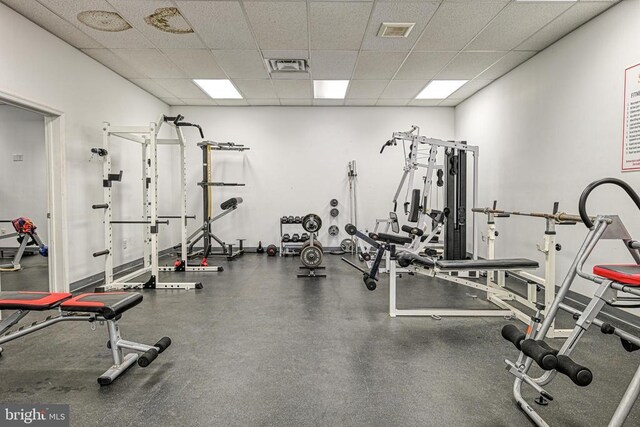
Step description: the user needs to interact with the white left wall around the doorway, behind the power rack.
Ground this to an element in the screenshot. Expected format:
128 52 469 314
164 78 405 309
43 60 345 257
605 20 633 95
0 4 170 281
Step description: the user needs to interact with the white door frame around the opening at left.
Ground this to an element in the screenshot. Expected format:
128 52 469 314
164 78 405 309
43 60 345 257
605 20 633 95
0 91 69 292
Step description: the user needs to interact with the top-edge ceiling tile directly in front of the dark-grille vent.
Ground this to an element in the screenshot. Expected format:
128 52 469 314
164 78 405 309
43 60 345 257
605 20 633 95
244 1 309 50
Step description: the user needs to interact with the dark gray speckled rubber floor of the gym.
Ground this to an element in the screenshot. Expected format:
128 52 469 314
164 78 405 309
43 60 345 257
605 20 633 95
0 254 640 426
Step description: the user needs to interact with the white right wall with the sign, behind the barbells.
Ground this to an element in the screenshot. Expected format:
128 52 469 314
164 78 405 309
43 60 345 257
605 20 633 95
456 0 640 293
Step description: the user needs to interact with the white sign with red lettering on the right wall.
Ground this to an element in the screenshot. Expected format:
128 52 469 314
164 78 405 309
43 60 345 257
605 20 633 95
622 64 640 172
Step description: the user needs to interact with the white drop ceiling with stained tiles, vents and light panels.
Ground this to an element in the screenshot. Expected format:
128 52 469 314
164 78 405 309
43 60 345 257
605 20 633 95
0 0 618 106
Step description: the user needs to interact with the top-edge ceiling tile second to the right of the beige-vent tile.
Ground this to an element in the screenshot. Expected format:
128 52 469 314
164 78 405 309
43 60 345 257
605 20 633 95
466 2 573 50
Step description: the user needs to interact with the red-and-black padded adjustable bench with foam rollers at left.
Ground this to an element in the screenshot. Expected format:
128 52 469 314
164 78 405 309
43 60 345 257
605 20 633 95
0 291 171 385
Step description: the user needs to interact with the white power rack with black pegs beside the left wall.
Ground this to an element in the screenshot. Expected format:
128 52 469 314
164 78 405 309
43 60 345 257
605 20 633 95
92 115 202 292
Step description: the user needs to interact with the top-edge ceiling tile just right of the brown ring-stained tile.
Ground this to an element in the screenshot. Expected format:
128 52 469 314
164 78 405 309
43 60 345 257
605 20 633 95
176 1 257 49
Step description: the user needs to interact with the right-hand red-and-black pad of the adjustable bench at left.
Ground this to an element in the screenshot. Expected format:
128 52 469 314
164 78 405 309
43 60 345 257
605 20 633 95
60 292 142 320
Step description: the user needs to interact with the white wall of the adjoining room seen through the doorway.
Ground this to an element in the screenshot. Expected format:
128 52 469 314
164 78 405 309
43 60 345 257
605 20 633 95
0 105 48 247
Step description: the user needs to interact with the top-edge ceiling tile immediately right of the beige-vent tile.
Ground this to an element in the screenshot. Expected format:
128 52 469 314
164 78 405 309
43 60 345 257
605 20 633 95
414 0 507 51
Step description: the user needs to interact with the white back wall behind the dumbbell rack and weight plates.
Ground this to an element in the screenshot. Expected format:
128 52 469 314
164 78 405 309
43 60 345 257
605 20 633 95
167 107 454 246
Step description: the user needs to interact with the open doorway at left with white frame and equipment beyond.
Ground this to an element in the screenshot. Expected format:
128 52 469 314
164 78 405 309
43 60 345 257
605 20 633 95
0 92 69 292
